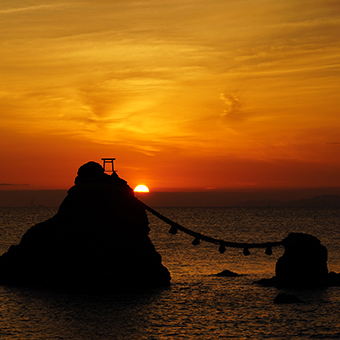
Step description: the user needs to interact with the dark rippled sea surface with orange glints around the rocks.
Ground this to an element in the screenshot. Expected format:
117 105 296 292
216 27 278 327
0 208 340 340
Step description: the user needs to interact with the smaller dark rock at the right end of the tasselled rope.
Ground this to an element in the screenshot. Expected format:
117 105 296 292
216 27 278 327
276 233 328 288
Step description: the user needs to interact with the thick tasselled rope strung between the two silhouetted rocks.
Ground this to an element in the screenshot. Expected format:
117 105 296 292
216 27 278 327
137 199 283 255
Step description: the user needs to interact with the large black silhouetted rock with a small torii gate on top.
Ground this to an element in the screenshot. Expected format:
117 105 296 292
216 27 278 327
0 162 170 291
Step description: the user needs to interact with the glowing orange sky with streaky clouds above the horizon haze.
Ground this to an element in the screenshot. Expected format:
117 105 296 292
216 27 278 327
0 0 340 191
